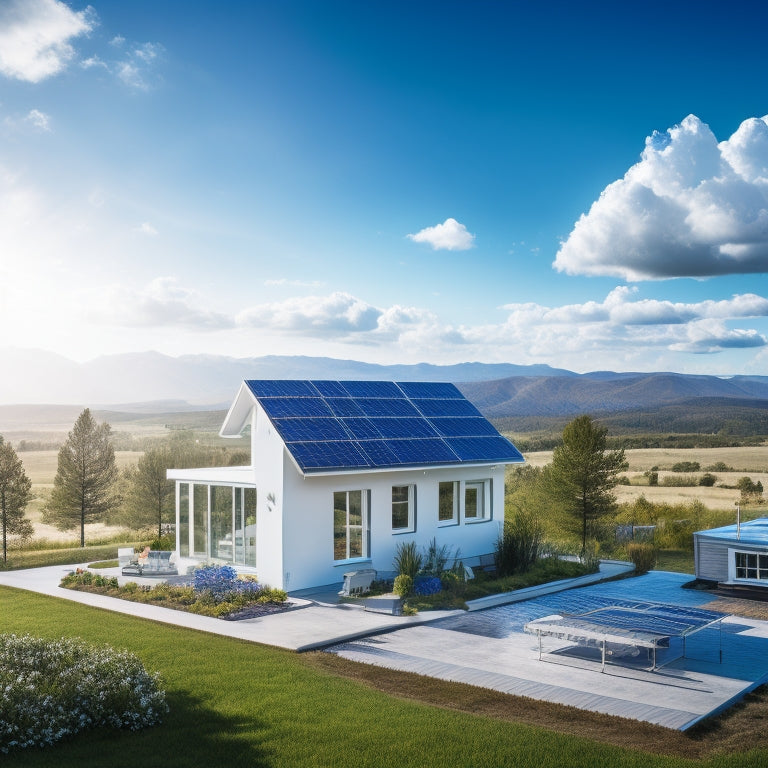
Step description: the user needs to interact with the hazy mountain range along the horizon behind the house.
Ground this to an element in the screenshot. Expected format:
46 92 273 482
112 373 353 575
0 349 768 426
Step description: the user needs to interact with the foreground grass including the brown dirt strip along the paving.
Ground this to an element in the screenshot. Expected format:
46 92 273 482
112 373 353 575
0 588 768 768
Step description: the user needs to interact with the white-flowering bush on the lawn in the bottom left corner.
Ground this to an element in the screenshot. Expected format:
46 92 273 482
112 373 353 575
0 635 168 754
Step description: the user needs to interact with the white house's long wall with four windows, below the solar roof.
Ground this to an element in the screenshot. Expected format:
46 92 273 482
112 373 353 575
280 460 504 590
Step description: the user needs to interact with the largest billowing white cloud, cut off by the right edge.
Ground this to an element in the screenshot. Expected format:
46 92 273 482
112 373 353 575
554 115 768 280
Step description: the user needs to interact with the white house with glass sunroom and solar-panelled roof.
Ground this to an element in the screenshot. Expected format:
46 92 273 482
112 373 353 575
168 380 524 591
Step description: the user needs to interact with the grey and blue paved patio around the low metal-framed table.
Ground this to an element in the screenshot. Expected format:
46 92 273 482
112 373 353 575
328 572 768 730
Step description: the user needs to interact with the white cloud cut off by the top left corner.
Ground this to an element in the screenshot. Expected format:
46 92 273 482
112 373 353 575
0 0 94 83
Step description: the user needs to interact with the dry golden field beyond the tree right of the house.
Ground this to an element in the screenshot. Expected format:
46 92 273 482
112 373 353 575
525 446 768 509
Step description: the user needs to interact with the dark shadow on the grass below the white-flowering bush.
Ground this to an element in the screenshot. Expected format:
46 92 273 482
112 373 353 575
2 692 272 768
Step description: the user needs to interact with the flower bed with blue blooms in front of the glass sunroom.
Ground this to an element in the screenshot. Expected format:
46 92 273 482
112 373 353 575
61 565 288 619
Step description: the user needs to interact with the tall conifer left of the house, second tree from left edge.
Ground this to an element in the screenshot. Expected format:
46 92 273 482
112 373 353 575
46 408 117 547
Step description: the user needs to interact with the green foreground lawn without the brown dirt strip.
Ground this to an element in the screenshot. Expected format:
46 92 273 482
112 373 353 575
0 587 768 768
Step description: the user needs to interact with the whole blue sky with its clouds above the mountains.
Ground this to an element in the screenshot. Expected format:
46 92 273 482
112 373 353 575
0 0 768 375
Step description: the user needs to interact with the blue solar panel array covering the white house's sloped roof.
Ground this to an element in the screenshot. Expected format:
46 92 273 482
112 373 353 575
246 380 523 473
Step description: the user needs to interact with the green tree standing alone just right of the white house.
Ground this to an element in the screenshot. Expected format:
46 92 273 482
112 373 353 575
546 415 627 555
